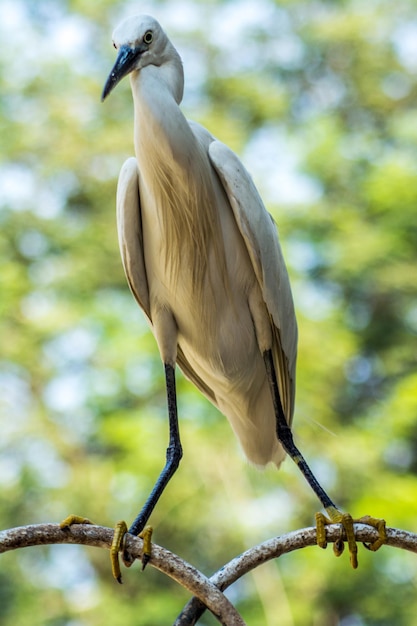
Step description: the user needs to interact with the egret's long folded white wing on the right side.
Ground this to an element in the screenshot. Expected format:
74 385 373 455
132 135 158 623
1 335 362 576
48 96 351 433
209 140 297 421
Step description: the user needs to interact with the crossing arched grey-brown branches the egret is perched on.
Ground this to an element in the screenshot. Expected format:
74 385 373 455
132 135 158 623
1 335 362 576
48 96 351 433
0 524 417 626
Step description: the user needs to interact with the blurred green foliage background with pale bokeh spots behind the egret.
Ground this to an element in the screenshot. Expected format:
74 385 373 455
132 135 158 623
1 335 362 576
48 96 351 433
0 0 417 626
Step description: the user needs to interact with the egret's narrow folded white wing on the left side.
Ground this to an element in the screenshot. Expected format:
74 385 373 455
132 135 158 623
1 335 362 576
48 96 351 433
116 157 152 324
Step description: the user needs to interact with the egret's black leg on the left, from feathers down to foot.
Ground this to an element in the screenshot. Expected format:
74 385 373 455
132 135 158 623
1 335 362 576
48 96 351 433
129 363 182 535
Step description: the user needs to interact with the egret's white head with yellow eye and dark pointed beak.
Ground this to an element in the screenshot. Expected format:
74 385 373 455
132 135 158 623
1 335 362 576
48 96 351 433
101 15 178 101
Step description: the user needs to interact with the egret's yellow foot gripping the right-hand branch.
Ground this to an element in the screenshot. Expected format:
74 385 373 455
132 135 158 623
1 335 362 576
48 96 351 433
316 507 387 569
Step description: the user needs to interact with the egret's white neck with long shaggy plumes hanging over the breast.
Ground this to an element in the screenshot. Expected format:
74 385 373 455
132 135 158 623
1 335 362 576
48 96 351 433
132 67 228 302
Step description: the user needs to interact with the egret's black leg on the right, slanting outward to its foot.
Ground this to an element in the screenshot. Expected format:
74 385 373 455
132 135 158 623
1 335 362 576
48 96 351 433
263 350 336 509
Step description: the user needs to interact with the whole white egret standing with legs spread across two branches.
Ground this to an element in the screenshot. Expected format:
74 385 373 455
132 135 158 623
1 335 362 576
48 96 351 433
102 15 386 577
